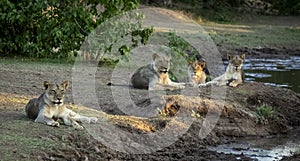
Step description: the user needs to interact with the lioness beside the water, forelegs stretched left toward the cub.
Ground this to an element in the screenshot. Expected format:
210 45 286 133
199 54 245 87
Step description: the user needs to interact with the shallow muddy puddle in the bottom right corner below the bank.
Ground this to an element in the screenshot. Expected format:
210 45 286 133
208 129 300 161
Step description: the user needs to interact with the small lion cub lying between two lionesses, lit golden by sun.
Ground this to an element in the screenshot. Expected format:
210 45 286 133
188 60 206 87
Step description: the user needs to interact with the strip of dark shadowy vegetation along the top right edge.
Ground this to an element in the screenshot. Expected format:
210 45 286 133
141 0 300 15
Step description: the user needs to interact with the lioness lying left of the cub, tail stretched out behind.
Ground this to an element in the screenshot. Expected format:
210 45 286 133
131 53 185 90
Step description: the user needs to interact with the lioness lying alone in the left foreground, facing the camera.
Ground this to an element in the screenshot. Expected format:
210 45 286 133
25 81 98 129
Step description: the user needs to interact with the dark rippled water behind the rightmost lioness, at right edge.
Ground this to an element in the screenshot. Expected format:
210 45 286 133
243 57 300 93
